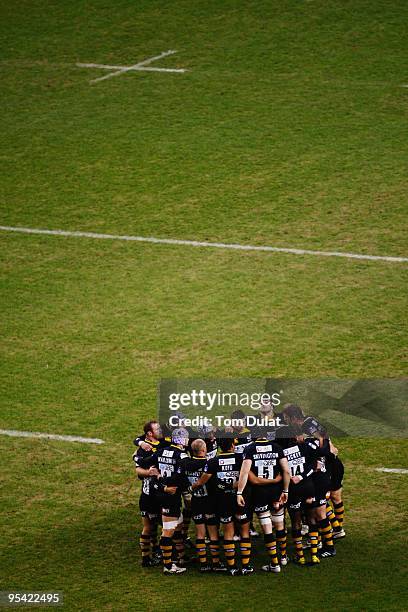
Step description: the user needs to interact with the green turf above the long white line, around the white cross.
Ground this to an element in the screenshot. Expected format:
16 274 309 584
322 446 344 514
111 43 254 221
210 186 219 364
1 0 408 255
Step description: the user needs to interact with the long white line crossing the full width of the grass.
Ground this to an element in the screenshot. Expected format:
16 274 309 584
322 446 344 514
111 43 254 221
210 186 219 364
0 225 408 263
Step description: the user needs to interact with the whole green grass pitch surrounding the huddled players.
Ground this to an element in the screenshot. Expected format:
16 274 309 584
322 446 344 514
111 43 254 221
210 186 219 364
0 0 408 611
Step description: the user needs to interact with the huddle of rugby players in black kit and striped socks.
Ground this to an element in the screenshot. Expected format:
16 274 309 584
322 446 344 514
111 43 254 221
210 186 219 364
133 404 345 575
